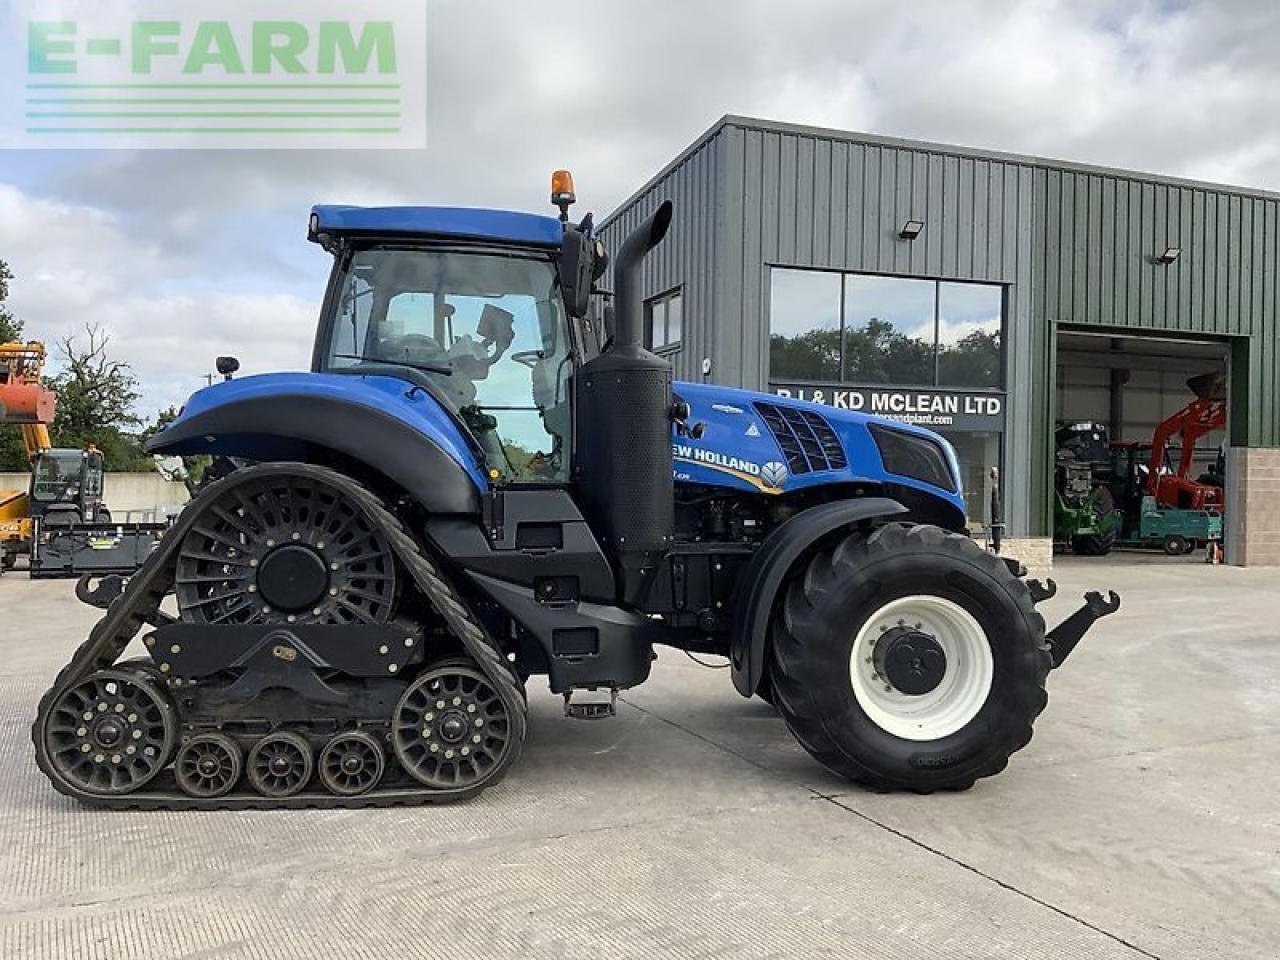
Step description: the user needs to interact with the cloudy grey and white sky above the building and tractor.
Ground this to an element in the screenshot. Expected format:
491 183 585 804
0 0 1280 417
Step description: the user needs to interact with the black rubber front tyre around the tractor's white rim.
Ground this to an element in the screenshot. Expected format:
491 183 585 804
771 524 1051 794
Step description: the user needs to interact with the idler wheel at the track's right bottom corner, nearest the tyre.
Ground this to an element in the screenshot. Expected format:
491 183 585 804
392 660 513 790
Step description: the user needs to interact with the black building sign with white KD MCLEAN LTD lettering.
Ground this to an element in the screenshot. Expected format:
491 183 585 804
769 383 1005 433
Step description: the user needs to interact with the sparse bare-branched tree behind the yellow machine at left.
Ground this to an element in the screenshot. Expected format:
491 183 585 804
50 324 151 470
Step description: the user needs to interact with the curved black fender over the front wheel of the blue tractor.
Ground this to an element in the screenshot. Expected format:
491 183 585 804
730 497 908 696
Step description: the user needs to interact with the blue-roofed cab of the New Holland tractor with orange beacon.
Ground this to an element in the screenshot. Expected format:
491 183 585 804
311 172 605 484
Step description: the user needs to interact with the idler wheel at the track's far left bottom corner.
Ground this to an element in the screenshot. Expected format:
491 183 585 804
44 669 178 796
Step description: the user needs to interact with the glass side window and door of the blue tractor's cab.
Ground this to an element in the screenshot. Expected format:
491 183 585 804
326 247 570 480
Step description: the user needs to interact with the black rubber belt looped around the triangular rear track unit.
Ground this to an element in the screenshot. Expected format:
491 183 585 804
31 463 526 810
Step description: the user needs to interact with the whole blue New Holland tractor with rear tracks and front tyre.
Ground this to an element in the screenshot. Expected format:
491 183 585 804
33 175 1119 809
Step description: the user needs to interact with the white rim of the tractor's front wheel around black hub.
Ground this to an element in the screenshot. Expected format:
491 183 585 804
849 594 995 740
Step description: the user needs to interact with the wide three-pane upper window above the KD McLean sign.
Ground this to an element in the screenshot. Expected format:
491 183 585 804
769 268 1004 389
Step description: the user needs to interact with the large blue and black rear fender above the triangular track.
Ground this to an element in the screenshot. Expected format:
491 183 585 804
146 374 488 513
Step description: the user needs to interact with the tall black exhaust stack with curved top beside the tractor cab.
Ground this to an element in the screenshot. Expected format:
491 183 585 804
575 201 676 603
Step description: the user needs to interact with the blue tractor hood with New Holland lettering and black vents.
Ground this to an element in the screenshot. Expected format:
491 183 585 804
672 383 964 511
